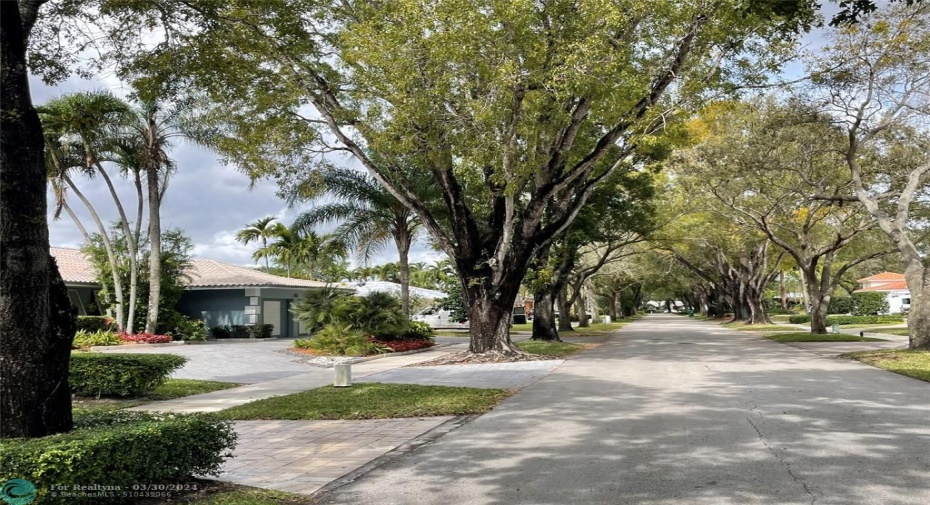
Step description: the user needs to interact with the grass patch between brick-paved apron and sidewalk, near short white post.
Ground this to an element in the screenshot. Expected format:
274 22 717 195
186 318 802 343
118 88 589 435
220 383 510 420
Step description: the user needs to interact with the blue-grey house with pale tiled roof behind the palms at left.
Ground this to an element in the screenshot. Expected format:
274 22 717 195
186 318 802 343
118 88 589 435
52 247 338 337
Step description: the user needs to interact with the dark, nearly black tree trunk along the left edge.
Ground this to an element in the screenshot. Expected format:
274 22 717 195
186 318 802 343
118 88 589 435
0 2 74 438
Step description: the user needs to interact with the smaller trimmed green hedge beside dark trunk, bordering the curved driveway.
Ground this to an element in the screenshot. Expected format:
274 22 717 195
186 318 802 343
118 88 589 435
70 353 187 396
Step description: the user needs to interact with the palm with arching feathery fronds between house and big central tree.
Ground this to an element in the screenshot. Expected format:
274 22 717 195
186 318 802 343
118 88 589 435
291 168 420 316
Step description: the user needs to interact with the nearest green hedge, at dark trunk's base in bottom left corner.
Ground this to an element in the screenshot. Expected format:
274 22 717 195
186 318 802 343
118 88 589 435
0 411 236 505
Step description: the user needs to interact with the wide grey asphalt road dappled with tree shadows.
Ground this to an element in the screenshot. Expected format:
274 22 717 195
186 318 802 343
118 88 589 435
320 315 930 505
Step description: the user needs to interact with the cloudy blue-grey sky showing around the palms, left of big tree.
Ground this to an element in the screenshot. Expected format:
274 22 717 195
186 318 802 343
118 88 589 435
31 78 439 266
